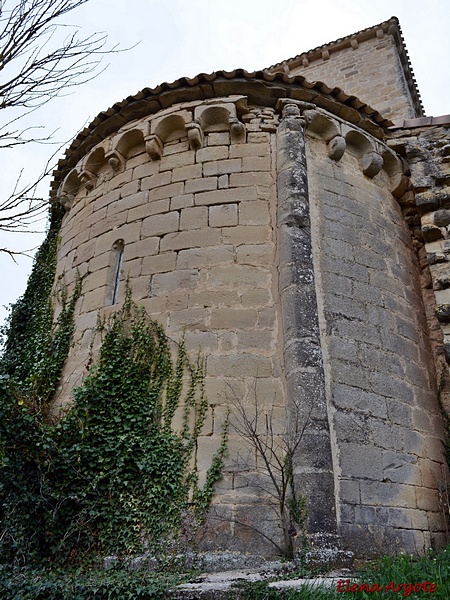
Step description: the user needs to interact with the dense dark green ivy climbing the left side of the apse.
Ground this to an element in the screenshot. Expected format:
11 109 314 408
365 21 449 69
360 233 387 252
0 214 226 564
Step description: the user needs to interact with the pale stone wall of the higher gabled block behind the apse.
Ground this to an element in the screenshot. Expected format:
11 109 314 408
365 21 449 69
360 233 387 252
289 30 416 119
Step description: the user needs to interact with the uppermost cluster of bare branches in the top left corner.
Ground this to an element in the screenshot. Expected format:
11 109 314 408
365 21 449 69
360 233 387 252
0 0 106 109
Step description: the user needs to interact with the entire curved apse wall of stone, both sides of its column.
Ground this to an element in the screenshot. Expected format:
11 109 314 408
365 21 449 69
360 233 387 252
51 85 448 554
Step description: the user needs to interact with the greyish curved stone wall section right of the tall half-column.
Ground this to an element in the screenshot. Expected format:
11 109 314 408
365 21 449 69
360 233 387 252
307 131 447 554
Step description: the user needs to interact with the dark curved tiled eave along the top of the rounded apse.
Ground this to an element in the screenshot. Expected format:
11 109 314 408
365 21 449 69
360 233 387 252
50 69 392 197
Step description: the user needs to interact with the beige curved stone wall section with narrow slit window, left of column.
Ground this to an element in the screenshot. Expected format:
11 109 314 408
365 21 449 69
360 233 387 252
51 99 285 553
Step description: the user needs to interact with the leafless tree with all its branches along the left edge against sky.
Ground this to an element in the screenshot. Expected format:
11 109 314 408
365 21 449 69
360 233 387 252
0 0 115 255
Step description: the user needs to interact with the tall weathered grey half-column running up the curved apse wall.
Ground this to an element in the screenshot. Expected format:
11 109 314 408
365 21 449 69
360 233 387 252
276 105 337 544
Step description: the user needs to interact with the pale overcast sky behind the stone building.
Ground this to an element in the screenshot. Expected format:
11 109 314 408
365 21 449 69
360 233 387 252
0 0 450 323
